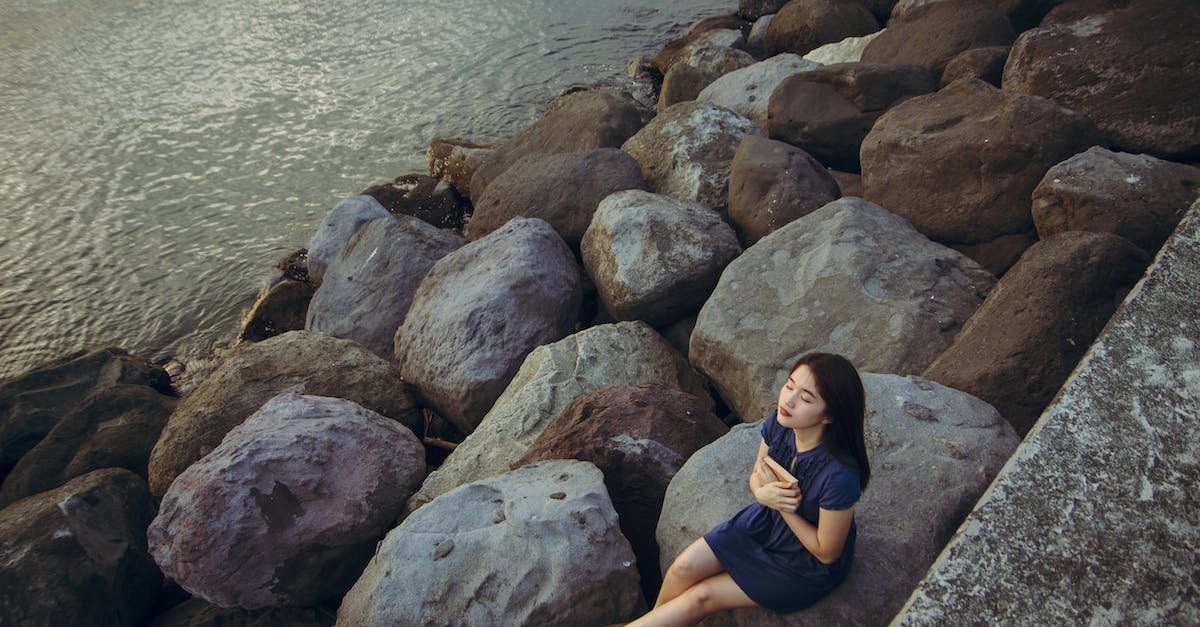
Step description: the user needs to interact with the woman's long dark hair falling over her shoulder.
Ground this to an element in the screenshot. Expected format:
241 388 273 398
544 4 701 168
787 353 871 490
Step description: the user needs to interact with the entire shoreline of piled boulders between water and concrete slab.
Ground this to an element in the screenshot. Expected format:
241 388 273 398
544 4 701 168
0 0 1200 626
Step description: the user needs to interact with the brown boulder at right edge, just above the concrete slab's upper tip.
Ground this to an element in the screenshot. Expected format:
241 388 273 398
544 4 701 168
1033 147 1200 255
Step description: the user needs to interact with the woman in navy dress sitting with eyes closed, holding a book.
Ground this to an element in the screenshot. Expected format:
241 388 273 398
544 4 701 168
631 353 871 626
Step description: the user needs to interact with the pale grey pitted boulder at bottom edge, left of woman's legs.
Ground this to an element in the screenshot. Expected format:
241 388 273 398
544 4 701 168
337 460 641 627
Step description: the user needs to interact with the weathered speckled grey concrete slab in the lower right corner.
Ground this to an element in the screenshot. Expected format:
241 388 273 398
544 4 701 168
893 202 1200 626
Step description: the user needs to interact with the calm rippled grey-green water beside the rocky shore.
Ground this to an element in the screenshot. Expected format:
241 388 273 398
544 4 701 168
0 0 737 377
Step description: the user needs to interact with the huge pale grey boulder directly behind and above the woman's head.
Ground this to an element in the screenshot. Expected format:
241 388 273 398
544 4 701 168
689 198 995 420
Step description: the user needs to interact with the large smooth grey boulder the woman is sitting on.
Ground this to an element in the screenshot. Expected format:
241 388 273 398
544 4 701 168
658 372 1020 626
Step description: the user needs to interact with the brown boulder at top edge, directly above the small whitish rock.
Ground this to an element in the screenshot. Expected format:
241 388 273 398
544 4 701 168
763 0 880 54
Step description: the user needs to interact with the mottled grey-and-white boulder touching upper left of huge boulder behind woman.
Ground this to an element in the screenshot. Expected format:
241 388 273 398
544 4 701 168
582 190 742 326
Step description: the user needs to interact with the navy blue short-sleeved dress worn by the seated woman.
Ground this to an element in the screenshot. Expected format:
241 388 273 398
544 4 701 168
704 412 860 613
